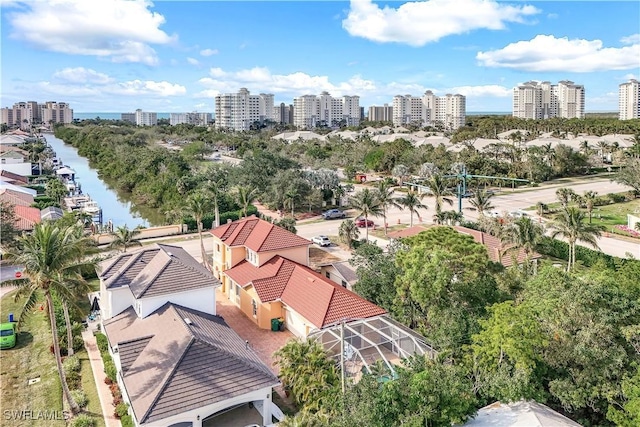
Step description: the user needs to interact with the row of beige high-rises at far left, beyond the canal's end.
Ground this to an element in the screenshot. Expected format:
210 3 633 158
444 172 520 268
0 101 73 129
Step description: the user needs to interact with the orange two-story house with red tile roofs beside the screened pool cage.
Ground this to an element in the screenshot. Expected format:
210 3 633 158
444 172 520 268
211 217 386 338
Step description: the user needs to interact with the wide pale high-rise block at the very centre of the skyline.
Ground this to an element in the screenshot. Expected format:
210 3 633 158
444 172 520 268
293 92 360 129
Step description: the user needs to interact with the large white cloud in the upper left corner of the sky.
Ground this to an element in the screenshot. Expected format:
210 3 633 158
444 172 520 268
7 0 176 65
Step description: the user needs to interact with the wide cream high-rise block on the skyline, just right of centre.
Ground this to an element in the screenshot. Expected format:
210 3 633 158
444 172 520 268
392 90 467 129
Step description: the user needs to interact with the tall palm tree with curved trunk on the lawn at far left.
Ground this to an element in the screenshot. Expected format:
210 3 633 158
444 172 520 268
2 221 95 413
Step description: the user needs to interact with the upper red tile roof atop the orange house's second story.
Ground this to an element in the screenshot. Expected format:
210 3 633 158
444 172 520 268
211 216 311 252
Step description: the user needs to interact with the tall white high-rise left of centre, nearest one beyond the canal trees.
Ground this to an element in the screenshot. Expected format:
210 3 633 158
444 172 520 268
216 88 273 131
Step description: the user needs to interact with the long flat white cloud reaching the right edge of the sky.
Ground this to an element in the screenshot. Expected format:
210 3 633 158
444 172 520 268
476 34 640 73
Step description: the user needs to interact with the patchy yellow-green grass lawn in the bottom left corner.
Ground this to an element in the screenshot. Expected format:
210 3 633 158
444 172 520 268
0 291 65 427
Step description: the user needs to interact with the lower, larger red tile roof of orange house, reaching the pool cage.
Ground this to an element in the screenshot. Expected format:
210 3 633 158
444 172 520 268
224 255 386 328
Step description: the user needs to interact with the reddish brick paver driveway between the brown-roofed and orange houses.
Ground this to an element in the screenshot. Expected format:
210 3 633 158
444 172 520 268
216 288 294 375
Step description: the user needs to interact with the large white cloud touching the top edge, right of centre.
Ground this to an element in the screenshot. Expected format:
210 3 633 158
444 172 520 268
342 0 539 46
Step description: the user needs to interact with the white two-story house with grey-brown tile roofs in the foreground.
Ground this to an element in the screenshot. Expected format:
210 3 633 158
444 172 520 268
99 244 279 427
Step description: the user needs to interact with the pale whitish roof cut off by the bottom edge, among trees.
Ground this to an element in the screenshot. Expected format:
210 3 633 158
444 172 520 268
464 400 580 427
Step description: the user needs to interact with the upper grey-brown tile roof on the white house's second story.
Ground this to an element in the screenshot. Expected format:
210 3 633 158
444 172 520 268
100 244 220 298
